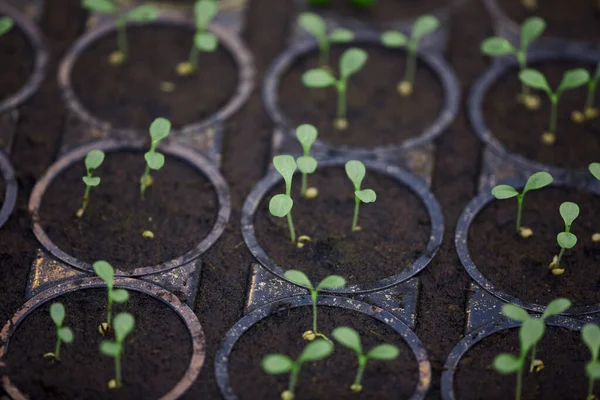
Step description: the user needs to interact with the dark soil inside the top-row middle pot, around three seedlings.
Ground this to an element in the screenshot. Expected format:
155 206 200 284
279 45 443 148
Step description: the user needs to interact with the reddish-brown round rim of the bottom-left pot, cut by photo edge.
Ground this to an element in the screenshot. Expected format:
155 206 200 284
0 278 206 400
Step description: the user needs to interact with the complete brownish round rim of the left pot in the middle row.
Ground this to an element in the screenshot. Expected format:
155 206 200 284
29 139 231 277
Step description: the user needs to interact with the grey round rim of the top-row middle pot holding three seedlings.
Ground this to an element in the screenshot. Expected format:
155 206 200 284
262 32 460 155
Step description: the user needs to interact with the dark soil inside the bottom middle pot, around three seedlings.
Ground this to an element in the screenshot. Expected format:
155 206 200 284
229 304 419 400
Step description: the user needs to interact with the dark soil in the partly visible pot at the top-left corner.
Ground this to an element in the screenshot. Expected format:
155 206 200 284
0 14 33 102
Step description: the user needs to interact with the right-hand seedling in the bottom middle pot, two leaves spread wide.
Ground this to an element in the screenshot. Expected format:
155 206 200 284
331 326 400 393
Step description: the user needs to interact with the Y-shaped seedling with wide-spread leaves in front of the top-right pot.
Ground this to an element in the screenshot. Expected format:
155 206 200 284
519 68 590 145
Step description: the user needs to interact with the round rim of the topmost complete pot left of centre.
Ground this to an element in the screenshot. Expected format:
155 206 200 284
58 10 255 135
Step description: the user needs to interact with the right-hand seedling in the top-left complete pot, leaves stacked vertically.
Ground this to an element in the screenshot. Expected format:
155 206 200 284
176 0 219 76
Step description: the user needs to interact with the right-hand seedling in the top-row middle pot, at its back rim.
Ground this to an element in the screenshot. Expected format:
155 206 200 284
381 15 440 96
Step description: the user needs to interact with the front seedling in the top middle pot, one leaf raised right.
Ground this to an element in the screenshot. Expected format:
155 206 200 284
302 47 368 130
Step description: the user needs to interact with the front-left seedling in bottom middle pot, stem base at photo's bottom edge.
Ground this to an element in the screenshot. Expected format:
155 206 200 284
261 339 333 400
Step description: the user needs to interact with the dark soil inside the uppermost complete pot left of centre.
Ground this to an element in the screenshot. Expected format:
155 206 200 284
72 25 238 129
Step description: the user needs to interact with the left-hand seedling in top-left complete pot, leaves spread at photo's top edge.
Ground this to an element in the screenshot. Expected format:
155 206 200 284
81 0 158 65
